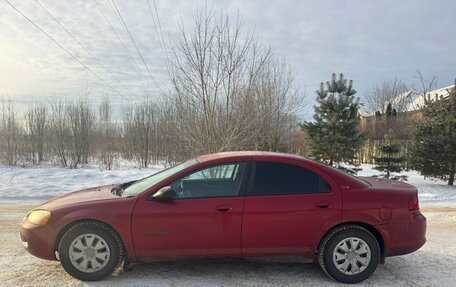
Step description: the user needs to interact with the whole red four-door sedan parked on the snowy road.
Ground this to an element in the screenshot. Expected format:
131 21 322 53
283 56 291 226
20 152 426 283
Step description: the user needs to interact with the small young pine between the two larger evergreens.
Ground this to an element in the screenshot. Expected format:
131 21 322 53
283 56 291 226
374 130 407 180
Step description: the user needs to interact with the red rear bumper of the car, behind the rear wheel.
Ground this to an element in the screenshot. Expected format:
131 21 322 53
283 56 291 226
378 210 426 257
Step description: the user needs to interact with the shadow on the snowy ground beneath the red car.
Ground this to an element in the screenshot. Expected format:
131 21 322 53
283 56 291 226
88 259 336 286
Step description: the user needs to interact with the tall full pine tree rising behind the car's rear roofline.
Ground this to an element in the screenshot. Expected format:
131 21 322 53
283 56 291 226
301 74 365 173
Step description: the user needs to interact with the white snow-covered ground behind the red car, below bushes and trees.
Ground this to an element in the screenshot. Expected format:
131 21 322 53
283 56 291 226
0 163 456 207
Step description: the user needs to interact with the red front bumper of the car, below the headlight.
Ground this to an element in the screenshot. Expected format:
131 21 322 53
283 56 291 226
20 222 57 260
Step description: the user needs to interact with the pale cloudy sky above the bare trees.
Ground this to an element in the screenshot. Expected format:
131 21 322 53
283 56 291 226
0 0 456 119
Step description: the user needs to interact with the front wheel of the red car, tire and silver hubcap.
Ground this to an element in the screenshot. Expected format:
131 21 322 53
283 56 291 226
58 221 124 281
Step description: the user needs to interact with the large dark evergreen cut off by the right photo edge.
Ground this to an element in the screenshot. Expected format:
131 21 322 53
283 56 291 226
411 81 456 185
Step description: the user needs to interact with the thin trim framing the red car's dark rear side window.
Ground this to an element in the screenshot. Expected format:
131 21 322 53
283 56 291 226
245 160 334 197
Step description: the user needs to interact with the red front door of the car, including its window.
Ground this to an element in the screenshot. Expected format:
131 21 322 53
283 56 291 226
132 163 246 258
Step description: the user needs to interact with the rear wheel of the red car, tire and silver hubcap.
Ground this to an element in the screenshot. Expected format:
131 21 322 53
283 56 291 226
318 225 380 284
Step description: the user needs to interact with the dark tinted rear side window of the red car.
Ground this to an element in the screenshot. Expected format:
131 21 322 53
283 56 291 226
249 162 331 195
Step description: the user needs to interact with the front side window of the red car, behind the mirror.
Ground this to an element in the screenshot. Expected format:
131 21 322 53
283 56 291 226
171 163 245 199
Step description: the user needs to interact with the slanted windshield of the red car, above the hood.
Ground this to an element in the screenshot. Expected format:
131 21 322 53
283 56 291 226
122 159 198 197
